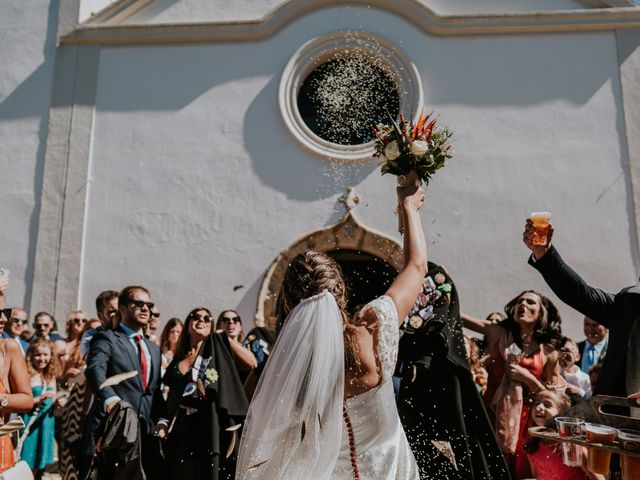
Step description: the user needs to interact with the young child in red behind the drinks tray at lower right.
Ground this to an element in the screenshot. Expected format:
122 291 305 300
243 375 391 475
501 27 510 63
524 390 605 480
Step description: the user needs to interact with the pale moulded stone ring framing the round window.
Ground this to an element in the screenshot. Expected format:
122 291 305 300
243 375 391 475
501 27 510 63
278 31 424 163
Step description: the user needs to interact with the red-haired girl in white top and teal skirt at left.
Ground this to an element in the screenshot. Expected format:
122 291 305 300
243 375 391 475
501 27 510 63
18 338 65 480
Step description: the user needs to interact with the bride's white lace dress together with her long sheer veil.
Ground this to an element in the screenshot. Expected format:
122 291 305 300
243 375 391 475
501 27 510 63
236 291 419 480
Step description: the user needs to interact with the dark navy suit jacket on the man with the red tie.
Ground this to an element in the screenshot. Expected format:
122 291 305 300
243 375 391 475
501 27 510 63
84 328 163 455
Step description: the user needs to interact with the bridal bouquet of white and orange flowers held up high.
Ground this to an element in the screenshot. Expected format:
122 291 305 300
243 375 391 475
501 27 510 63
374 112 453 186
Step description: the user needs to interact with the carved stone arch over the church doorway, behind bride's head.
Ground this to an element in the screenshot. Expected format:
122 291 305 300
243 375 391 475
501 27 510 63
254 211 403 329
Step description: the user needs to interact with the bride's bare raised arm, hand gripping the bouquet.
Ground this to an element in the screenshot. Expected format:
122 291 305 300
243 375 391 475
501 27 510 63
387 185 429 325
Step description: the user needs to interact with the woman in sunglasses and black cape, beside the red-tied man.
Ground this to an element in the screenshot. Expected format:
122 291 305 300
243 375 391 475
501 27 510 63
160 307 246 480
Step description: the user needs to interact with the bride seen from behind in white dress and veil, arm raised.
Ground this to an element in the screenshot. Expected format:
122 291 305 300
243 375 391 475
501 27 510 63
236 182 427 480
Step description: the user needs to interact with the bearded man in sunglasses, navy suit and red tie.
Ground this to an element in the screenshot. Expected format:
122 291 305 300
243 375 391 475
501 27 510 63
83 286 162 479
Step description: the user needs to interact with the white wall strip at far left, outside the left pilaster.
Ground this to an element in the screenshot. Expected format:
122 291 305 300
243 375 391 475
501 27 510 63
0 0 59 313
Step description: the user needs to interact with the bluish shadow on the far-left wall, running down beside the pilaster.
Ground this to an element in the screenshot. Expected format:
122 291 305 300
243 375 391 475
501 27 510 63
0 0 60 306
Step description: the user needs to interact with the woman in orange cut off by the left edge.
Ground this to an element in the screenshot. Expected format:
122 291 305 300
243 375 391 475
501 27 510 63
0 281 33 473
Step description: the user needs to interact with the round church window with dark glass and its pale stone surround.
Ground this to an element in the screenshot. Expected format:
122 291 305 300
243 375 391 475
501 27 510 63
279 32 422 162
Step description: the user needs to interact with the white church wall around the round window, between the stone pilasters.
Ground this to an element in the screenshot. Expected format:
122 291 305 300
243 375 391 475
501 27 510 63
80 6 637 338
